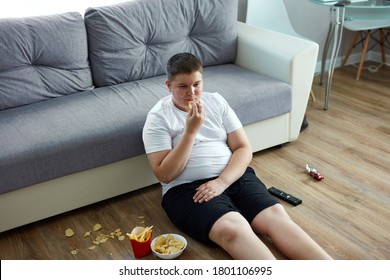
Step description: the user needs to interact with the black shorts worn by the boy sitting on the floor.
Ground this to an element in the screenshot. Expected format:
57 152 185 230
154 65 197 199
162 167 278 245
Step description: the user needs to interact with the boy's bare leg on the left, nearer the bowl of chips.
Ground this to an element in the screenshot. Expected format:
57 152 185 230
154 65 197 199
209 212 275 260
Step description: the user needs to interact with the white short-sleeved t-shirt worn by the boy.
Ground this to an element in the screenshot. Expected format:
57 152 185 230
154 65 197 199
142 92 242 195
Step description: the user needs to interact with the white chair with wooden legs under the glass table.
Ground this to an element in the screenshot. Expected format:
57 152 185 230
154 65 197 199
341 20 390 80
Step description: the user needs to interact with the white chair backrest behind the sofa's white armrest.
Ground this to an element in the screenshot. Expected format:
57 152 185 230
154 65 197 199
246 0 301 37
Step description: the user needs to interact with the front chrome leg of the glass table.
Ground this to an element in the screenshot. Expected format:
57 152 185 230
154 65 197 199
324 6 345 110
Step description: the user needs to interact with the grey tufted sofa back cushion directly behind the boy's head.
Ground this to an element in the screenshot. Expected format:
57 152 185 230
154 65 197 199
84 0 238 86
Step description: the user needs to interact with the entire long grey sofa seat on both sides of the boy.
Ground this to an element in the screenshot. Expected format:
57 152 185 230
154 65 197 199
0 64 291 194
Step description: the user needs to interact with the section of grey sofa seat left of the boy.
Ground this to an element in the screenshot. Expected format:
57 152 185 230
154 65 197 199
0 77 168 196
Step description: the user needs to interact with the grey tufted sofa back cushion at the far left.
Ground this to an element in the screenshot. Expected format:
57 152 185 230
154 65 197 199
0 12 93 110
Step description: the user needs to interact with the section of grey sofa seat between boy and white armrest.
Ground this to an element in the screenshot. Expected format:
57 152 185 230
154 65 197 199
203 64 292 126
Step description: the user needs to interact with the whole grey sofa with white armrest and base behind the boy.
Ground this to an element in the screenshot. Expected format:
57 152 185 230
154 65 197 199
0 0 318 232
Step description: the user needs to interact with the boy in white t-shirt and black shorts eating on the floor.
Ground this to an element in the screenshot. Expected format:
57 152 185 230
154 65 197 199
143 53 330 259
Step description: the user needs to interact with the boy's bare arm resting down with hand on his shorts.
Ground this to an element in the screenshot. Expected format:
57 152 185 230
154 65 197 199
194 128 252 203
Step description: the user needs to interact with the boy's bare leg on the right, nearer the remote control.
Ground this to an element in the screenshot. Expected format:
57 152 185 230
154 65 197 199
251 204 332 260
